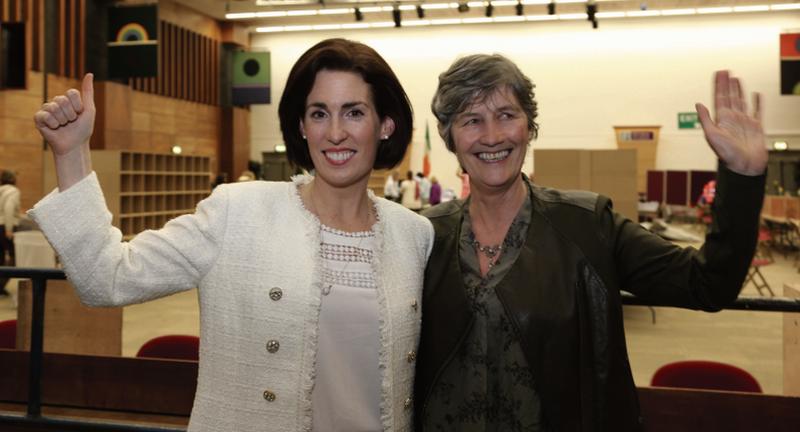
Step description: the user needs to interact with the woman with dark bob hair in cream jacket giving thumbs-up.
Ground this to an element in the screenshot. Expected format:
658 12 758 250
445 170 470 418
31 39 433 431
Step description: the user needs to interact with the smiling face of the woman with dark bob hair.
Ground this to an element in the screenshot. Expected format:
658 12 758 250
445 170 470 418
300 70 394 189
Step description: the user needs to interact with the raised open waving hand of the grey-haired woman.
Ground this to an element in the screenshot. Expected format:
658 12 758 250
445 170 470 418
695 71 768 176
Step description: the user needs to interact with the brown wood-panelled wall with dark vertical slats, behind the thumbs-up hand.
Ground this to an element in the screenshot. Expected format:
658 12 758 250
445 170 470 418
0 0 228 208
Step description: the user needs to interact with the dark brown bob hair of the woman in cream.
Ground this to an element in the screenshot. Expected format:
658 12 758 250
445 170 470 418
278 38 414 170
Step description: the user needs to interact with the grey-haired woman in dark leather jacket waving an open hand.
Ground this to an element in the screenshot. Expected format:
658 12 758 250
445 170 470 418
415 55 767 431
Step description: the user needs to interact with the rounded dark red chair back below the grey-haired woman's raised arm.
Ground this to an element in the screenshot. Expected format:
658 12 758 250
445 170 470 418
650 360 762 393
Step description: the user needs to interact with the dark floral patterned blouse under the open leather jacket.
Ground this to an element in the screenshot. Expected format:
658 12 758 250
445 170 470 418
424 184 543 432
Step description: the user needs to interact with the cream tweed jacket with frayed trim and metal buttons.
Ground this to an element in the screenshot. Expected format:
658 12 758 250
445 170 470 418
29 173 433 431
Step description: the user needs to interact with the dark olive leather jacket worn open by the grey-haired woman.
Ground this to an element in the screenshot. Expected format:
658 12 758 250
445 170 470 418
415 166 765 432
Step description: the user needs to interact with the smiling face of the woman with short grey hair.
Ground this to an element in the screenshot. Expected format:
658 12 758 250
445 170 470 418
452 87 531 192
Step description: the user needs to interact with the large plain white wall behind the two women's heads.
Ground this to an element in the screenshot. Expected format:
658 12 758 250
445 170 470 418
251 12 800 191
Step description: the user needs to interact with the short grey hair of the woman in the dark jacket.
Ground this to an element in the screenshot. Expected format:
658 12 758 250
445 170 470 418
431 54 539 153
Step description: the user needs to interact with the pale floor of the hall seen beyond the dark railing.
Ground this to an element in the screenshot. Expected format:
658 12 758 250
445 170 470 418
0 224 800 394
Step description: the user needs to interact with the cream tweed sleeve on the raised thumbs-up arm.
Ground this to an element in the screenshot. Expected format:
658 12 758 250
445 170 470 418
28 173 228 306
